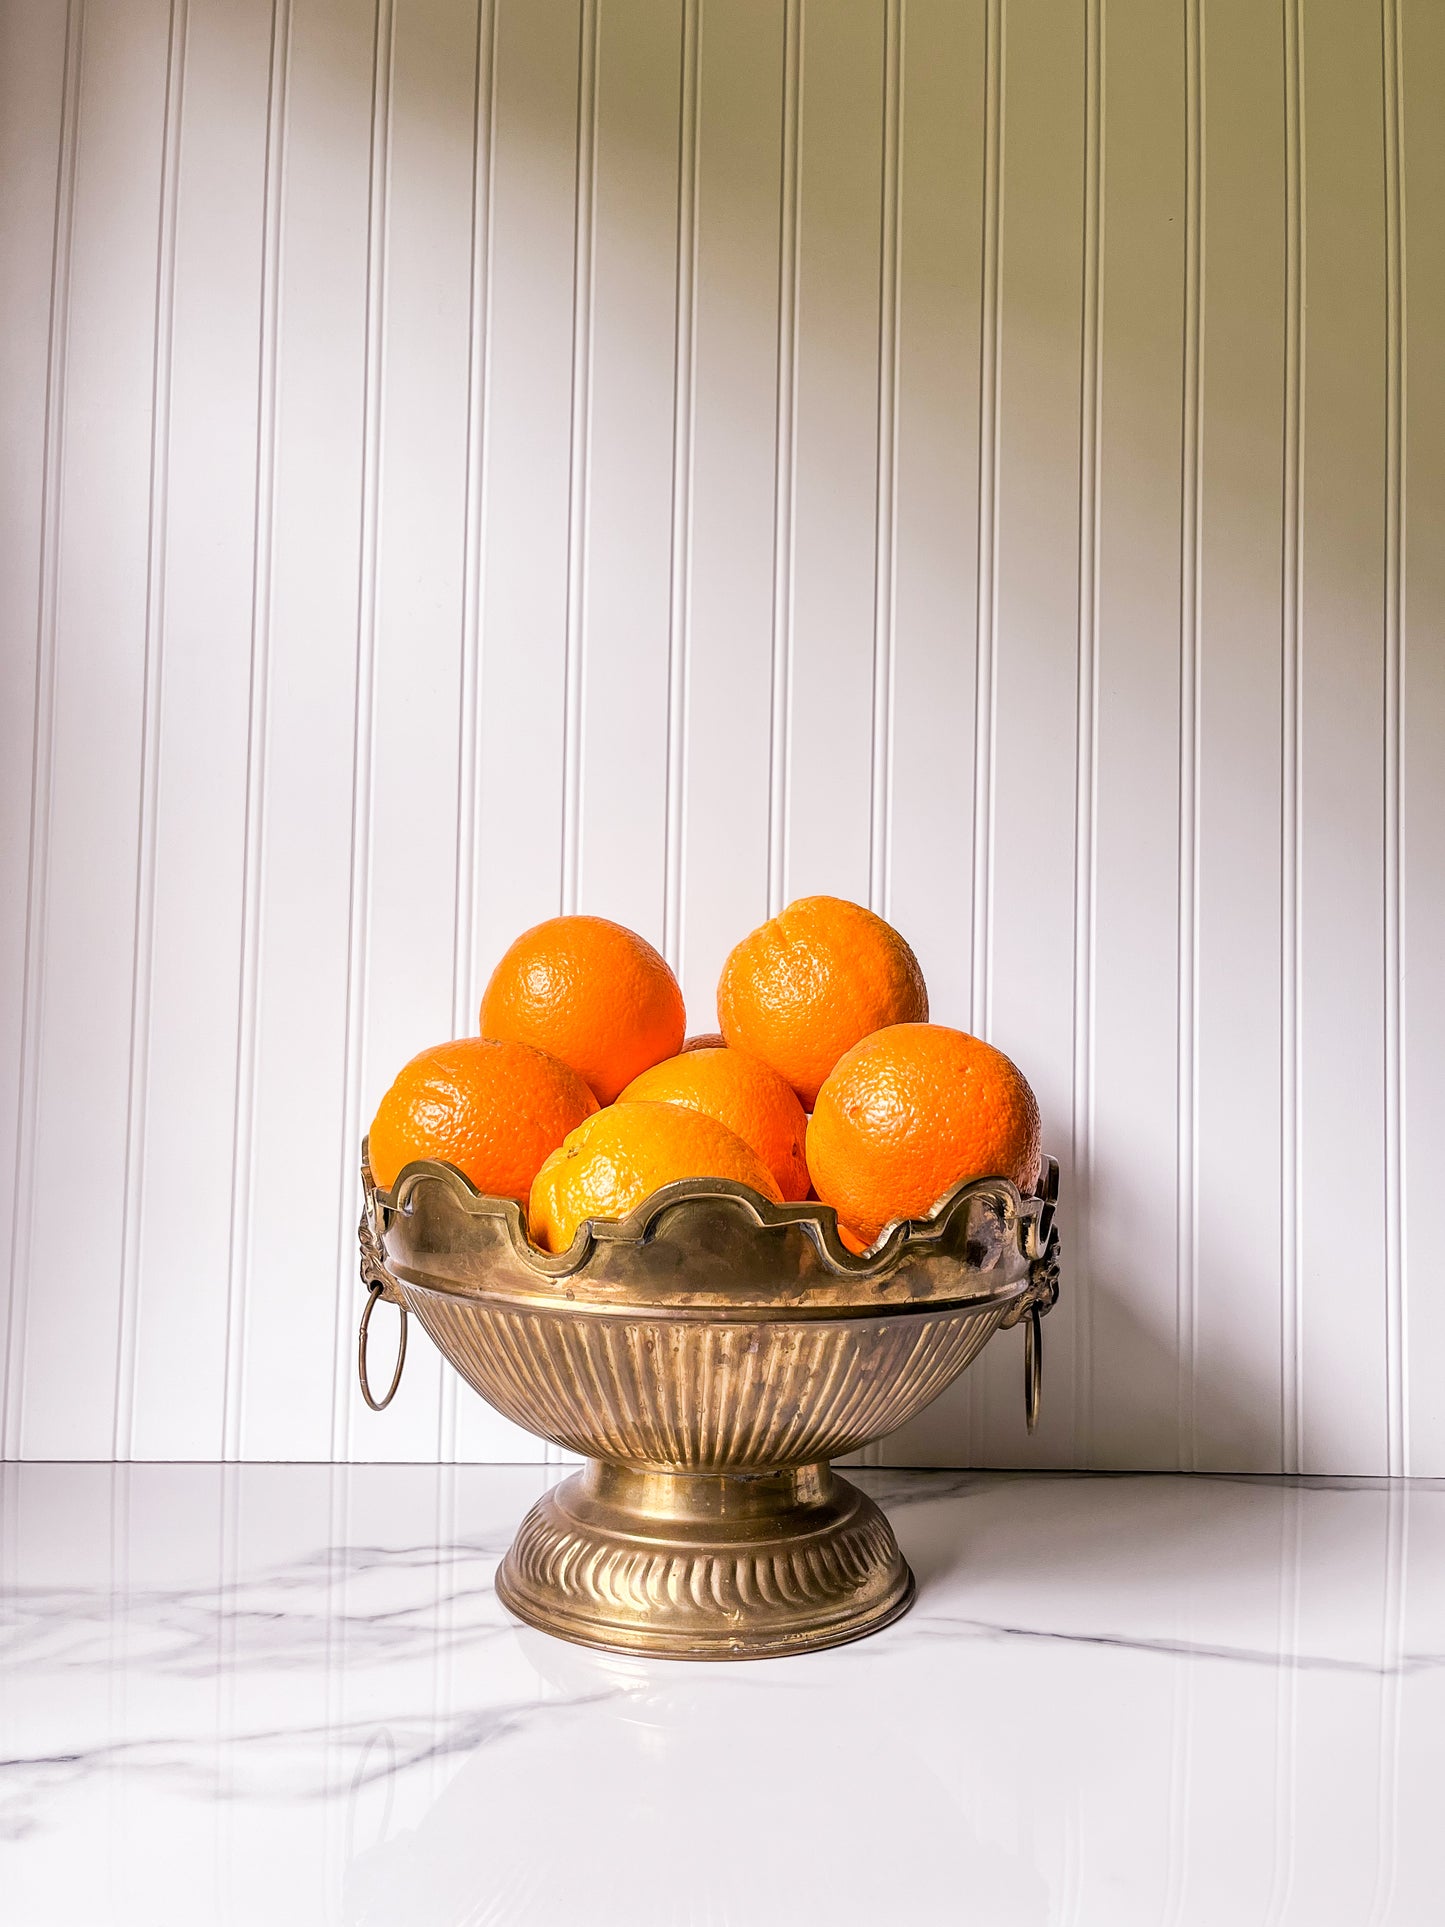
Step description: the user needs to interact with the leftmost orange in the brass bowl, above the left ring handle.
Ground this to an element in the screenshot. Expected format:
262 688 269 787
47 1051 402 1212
370 1037 597 1202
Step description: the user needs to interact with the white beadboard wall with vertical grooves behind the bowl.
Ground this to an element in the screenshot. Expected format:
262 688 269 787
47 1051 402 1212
0 0 1445 1476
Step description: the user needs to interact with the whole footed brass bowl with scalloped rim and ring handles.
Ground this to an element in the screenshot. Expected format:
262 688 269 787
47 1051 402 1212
358 1147 1058 1659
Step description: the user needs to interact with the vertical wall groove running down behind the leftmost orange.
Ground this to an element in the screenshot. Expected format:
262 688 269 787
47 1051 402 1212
437 0 497 1463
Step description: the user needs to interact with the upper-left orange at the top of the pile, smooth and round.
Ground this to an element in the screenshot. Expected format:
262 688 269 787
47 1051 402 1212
482 917 686 1104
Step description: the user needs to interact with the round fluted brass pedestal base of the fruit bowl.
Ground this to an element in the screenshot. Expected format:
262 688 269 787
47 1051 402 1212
497 1459 913 1659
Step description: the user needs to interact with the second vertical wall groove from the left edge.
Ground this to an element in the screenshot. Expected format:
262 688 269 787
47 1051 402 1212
110 0 187 1459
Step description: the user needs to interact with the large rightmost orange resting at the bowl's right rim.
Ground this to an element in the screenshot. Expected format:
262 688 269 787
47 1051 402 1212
807 1023 1038 1245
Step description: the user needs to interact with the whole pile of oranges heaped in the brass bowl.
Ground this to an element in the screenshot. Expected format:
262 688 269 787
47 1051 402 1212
370 896 1040 1251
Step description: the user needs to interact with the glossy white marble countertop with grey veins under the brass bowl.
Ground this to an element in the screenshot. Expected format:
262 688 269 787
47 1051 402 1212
0 1465 1445 1927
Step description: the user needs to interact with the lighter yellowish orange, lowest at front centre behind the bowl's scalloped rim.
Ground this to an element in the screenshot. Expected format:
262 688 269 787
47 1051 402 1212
528 1100 782 1251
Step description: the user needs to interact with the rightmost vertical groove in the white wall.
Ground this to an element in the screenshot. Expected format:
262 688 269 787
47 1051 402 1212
1381 0 1410 1476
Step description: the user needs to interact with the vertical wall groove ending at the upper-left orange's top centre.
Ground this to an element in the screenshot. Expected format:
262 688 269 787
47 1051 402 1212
561 0 597 915
